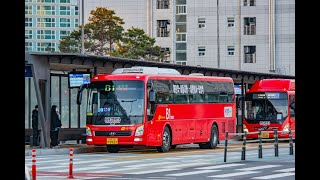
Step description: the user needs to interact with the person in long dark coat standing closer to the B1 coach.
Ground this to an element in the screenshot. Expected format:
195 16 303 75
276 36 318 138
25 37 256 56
50 105 62 147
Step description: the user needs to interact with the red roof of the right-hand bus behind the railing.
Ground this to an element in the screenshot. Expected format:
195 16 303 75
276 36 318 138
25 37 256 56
248 79 295 92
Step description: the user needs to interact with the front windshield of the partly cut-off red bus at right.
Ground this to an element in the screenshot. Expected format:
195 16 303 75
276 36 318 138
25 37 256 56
245 92 288 124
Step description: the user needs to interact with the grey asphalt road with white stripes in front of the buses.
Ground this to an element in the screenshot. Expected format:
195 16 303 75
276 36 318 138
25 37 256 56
25 144 295 180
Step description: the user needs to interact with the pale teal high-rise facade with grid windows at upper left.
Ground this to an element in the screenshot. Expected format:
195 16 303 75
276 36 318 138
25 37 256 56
25 0 80 52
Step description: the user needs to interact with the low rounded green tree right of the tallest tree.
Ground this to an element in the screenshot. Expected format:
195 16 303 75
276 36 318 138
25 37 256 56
112 27 164 61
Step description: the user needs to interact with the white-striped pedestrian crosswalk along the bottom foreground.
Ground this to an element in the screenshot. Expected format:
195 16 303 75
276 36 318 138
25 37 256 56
25 151 295 180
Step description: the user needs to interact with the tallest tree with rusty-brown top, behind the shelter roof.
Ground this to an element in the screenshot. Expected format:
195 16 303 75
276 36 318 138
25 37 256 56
88 7 124 55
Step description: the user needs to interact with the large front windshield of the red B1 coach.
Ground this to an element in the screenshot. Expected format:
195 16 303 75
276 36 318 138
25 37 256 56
87 80 144 125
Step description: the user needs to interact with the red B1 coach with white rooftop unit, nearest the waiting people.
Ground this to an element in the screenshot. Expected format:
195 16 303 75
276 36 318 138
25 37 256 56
78 67 236 153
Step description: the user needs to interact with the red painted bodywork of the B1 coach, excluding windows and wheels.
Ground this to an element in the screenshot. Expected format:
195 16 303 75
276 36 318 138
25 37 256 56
87 73 236 146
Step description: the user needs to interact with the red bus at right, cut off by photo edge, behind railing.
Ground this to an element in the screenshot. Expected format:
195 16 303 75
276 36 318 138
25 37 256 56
243 79 295 138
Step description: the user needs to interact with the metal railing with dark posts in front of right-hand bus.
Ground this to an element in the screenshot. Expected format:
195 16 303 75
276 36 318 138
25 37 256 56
224 130 295 162
